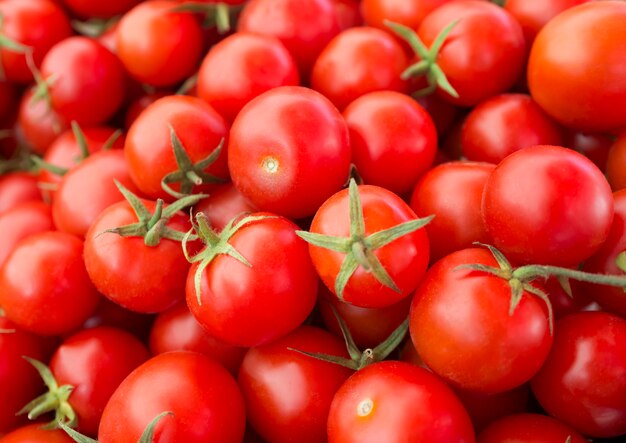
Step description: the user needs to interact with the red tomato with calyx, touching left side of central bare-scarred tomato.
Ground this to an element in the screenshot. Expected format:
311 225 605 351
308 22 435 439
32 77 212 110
124 95 228 201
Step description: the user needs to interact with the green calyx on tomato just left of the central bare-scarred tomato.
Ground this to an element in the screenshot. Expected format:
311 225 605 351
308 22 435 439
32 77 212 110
161 125 225 198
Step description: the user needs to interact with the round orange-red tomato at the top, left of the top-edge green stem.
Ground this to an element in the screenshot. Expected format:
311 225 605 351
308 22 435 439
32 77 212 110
116 0 203 86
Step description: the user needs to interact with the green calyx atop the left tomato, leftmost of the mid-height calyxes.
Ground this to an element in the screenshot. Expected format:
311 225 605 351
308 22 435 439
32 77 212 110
98 180 207 247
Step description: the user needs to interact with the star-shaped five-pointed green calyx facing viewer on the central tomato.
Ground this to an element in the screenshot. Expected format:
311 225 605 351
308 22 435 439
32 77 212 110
296 179 434 300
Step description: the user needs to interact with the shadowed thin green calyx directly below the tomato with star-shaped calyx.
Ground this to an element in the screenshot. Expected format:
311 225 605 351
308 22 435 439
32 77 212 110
288 306 409 371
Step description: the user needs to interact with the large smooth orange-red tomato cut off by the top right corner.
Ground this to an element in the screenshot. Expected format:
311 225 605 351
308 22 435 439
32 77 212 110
528 1 626 132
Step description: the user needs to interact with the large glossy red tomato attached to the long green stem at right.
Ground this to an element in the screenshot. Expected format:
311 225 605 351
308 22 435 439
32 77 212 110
409 248 552 394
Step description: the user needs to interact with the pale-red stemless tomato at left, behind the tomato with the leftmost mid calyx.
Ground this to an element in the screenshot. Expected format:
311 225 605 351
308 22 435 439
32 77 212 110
52 150 136 237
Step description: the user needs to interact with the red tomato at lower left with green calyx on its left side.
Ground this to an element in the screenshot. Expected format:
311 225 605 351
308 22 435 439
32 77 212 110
50 326 150 436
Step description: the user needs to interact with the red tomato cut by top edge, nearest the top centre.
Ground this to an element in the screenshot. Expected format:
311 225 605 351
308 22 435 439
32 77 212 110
237 0 341 78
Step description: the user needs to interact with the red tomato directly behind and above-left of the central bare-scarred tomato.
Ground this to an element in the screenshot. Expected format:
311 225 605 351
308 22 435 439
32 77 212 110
198 32 300 122
